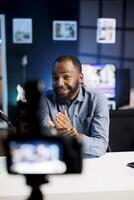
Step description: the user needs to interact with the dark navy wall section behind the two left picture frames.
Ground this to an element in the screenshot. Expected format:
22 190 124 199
0 0 79 124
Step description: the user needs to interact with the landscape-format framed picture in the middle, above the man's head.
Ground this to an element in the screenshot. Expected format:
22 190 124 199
53 20 77 41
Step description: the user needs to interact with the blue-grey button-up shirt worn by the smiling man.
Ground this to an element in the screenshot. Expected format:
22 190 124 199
41 86 109 157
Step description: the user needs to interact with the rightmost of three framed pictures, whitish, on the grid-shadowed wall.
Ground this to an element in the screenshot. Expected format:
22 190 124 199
96 18 116 43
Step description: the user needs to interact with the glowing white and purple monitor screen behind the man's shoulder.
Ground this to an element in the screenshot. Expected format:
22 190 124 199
82 64 116 99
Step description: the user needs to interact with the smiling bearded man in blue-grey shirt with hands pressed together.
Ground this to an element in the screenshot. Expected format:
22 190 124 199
41 56 109 157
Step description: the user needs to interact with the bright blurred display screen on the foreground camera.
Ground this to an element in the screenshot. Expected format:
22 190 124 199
9 140 66 174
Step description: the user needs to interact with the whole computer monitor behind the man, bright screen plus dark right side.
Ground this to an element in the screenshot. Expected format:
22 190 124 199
82 64 130 109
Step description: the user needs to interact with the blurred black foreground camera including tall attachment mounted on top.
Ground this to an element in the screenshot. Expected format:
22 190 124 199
5 81 82 175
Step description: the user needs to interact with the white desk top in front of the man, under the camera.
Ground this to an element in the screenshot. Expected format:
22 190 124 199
0 152 134 200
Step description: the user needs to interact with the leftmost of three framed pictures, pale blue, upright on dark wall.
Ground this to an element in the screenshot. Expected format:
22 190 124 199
13 18 33 44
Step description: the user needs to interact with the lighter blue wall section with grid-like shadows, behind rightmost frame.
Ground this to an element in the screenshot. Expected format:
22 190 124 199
78 0 134 108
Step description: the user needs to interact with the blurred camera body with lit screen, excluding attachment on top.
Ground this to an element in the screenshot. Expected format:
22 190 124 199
5 134 82 175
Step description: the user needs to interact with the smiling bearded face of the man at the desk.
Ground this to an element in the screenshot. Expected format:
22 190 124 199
52 60 83 101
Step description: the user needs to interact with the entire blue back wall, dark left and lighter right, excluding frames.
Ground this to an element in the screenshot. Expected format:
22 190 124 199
0 0 134 125
